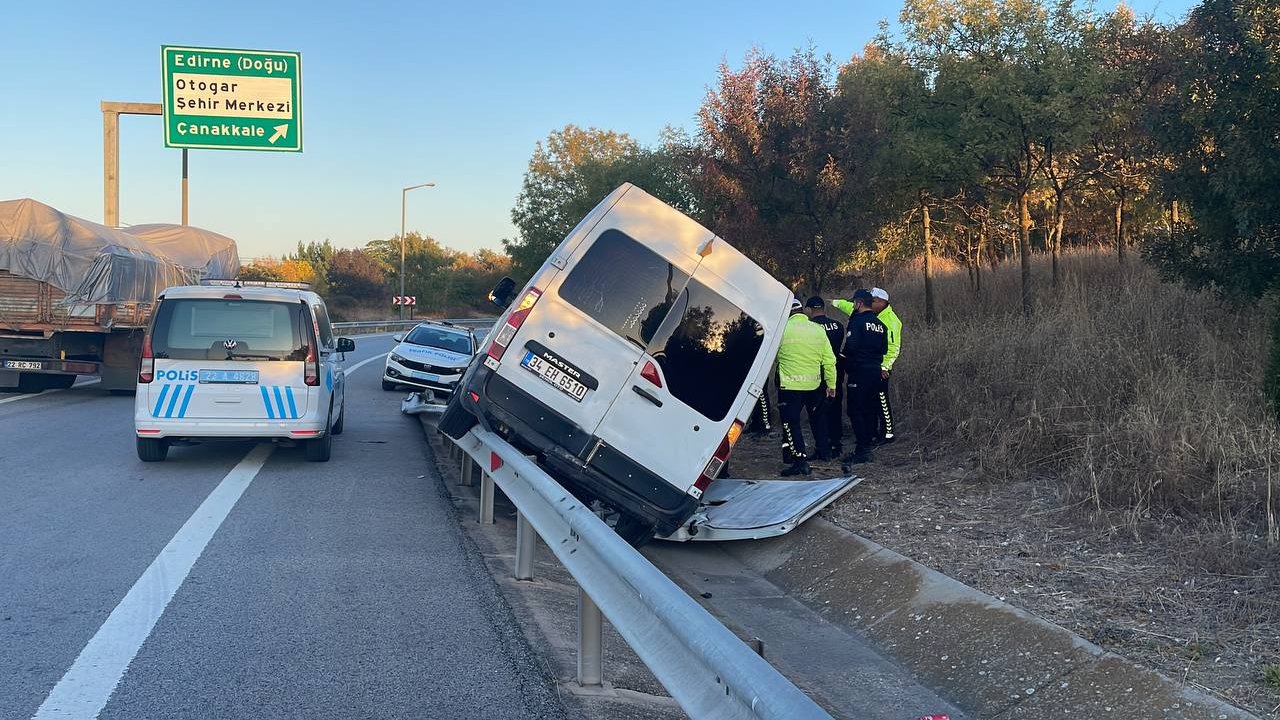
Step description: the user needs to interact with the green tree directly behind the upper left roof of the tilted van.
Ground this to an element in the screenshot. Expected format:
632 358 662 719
502 126 692 278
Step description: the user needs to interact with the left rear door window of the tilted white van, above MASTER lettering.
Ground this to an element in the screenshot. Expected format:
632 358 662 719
559 229 689 347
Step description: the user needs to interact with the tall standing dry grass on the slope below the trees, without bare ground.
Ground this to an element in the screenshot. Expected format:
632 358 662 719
887 252 1280 537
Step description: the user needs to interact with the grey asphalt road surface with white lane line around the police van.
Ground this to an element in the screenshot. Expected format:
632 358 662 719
0 337 563 720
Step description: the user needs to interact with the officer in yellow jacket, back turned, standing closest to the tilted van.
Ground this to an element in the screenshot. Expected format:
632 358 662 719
778 294 836 475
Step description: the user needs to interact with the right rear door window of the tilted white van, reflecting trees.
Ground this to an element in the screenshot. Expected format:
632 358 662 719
649 279 764 421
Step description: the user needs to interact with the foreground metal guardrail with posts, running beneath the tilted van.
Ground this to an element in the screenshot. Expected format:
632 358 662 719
440 427 831 720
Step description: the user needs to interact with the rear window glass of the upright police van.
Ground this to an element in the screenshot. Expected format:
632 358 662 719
151 297 311 360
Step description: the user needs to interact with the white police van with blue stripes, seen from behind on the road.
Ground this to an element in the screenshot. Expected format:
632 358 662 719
133 281 356 462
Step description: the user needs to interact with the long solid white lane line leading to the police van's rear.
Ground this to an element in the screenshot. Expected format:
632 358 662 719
33 442 275 720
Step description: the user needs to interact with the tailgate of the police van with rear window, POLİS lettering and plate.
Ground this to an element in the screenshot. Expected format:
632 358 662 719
140 297 314 420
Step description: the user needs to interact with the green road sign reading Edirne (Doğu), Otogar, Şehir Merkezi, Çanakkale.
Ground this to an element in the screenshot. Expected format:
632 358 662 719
160 45 302 152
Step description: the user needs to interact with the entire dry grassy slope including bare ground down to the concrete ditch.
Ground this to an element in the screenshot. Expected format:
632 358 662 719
733 245 1280 719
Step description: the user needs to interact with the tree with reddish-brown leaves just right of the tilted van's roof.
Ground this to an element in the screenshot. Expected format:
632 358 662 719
695 50 883 292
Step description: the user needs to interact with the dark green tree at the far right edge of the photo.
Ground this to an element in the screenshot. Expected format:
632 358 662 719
1148 0 1280 404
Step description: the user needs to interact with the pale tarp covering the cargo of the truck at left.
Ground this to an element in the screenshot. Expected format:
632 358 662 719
0 199 239 305
